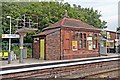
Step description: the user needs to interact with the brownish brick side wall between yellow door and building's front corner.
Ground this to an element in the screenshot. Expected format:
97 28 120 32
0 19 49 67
46 30 60 60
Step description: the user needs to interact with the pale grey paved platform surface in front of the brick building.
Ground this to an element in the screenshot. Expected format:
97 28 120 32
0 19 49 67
0 53 120 68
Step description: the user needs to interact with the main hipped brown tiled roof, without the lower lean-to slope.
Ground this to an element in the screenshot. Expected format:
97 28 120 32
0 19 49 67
43 17 100 30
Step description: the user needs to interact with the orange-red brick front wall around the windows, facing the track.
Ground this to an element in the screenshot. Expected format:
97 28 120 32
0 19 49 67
61 29 99 59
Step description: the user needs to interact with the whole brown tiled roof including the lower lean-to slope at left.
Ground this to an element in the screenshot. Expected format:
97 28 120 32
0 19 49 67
33 17 100 37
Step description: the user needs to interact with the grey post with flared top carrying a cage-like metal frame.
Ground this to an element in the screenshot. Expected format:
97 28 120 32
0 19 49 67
16 14 38 63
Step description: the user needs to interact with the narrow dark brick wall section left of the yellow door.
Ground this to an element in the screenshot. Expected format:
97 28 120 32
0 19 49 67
32 40 40 59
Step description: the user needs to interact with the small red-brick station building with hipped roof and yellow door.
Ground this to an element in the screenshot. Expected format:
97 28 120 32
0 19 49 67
32 17 100 60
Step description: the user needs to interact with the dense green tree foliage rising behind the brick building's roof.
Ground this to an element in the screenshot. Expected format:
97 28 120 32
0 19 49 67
2 2 107 42
